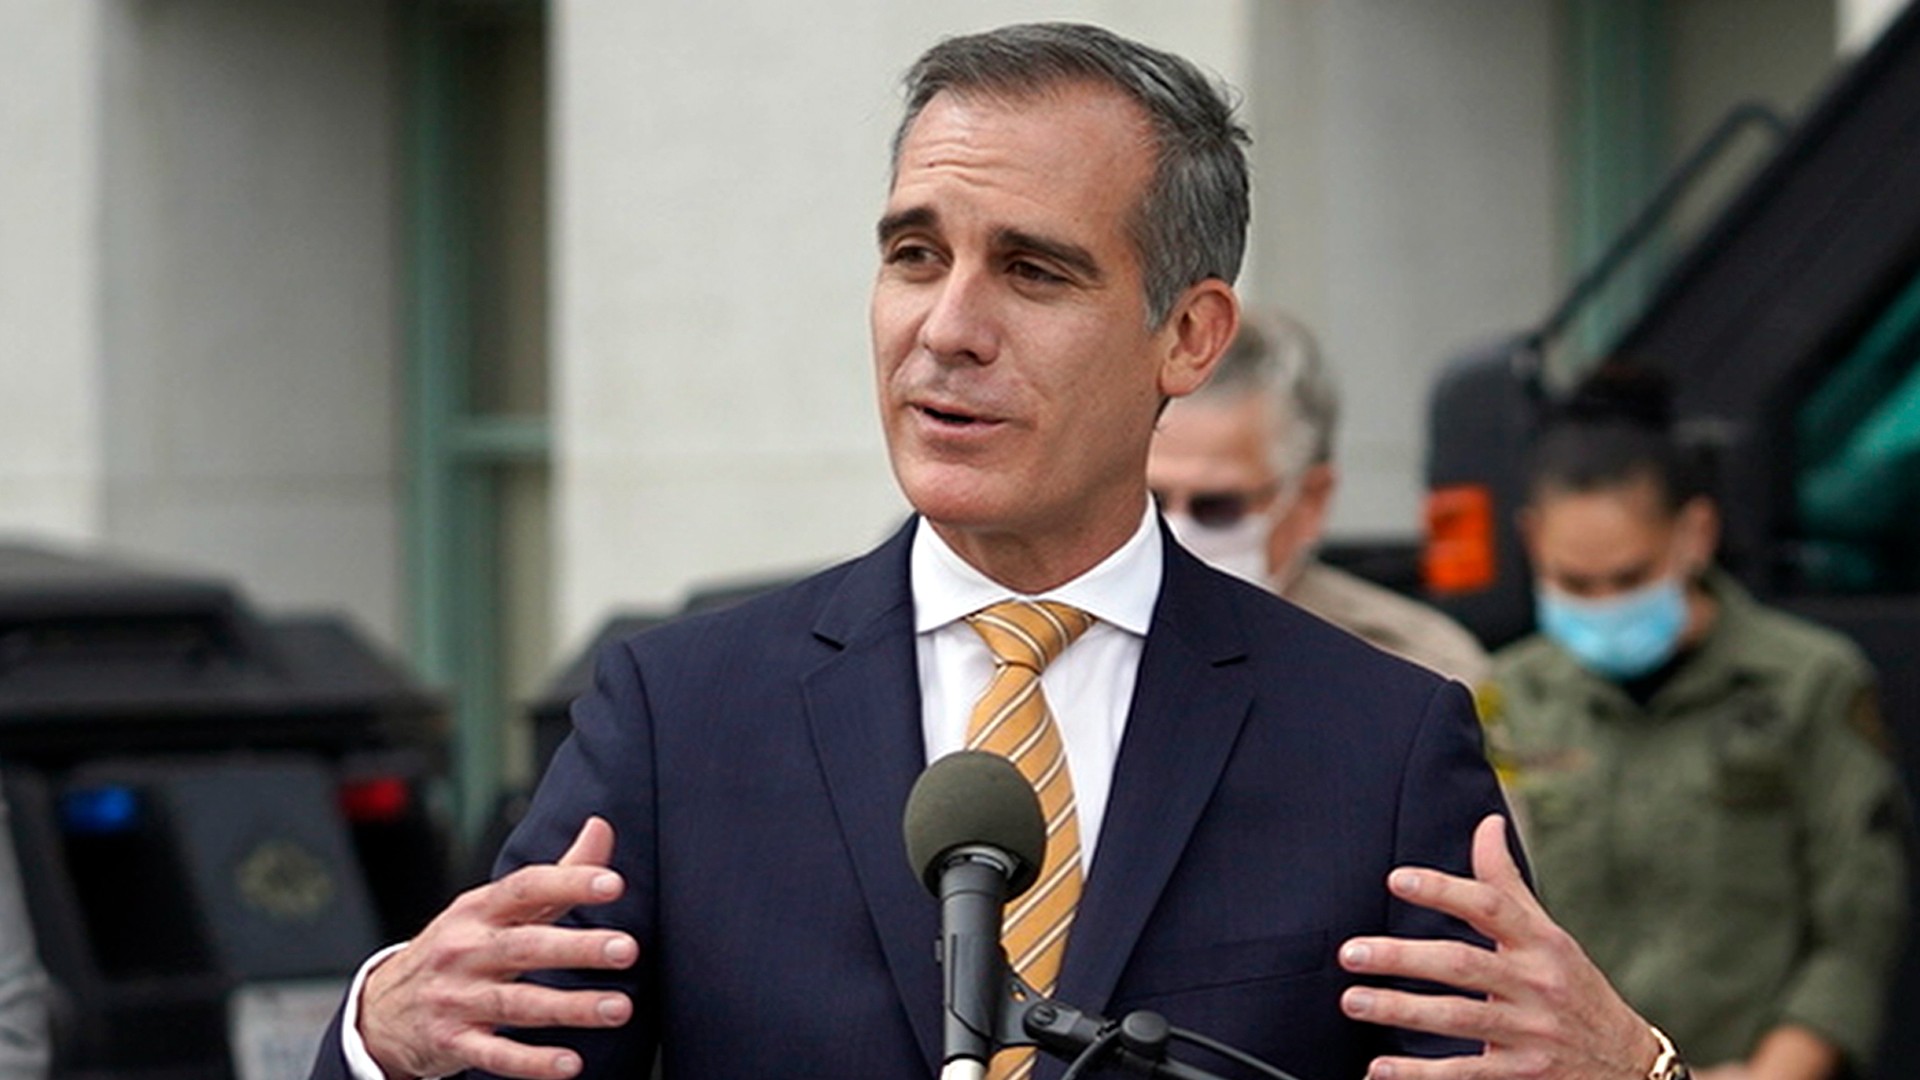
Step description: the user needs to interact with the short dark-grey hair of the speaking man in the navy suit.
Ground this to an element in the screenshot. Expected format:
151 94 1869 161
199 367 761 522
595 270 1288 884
893 23 1250 329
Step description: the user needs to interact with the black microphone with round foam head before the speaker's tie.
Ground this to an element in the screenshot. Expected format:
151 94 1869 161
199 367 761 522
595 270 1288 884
902 749 1046 1080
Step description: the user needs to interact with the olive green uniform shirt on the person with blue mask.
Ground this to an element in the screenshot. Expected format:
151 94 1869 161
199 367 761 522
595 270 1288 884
1488 573 1907 1065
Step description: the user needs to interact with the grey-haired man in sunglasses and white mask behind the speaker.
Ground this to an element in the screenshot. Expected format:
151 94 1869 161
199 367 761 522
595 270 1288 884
1146 317 1488 686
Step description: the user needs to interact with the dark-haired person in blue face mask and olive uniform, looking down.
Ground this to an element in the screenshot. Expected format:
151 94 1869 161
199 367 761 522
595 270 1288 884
1488 365 1907 1080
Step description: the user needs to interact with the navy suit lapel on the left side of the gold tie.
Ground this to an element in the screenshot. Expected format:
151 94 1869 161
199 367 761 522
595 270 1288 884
803 527 941 1070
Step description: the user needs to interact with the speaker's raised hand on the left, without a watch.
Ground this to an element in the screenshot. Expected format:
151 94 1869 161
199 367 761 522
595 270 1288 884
359 817 639 1080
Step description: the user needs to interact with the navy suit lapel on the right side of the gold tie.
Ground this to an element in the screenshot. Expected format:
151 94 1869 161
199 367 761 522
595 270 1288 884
1058 534 1254 1011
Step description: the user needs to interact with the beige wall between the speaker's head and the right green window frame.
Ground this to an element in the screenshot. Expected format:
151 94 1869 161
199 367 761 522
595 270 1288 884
1244 0 1563 536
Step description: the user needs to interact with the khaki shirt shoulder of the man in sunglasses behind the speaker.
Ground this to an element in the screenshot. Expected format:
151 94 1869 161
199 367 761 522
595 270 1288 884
1281 559 1488 686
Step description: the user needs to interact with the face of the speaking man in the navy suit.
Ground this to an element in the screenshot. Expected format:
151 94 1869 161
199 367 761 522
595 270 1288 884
872 86 1213 584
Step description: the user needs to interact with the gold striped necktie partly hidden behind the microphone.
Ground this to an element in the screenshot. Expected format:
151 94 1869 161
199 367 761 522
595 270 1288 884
966 600 1094 1080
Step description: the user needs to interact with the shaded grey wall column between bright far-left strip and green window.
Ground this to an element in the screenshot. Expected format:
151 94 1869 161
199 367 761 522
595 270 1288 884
96 0 403 642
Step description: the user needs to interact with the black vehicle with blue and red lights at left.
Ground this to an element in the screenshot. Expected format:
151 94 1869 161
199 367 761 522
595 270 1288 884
0 546 451 1080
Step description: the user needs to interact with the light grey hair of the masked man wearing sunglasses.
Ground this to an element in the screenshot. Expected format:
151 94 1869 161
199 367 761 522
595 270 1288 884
1194 315 1340 484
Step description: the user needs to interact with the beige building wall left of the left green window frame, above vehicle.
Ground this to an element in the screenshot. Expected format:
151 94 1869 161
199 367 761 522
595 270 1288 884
0 0 401 642
